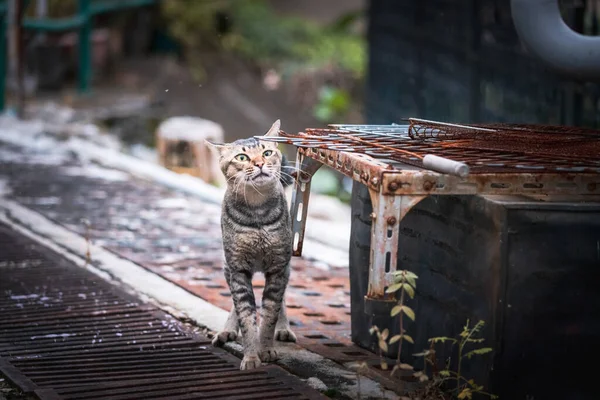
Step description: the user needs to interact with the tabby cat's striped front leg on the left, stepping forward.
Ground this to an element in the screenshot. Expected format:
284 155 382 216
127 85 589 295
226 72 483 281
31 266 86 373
225 268 261 370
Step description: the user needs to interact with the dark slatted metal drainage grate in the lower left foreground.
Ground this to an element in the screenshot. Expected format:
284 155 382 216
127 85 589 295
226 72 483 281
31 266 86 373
0 225 324 400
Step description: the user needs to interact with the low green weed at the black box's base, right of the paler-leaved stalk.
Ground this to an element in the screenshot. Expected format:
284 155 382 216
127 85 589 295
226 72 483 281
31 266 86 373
414 320 498 400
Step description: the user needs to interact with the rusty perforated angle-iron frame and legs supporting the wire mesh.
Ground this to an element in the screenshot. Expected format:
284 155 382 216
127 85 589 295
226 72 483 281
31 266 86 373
291 147 600 301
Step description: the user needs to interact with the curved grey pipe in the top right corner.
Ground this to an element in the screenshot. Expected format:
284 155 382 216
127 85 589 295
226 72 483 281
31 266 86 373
511 0 600 81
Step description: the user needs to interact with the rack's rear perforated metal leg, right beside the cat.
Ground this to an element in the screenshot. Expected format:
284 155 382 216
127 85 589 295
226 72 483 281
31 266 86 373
290 151 323 257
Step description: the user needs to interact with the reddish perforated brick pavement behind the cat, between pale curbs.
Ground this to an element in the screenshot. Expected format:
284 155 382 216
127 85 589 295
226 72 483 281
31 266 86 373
0 138 367 361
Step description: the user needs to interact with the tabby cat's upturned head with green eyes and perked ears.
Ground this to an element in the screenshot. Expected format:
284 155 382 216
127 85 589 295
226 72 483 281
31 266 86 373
208 120 283 191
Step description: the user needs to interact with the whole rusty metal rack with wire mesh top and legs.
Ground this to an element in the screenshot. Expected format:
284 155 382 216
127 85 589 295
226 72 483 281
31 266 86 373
257 118 600 308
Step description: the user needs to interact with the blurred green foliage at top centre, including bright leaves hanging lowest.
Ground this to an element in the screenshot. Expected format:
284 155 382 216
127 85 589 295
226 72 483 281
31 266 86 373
162 0 367 123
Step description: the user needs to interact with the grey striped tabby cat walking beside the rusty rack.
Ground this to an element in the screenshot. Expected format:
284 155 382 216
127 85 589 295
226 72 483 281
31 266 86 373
210 120 296 369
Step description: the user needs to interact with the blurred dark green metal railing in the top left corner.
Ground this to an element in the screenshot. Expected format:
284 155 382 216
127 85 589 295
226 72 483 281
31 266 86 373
0 0 159 111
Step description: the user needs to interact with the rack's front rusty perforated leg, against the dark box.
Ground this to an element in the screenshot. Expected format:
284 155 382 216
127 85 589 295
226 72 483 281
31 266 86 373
366 190 427 301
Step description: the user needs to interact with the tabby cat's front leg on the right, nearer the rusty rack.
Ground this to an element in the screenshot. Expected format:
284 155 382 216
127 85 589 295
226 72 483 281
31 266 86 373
259 266 290 362
